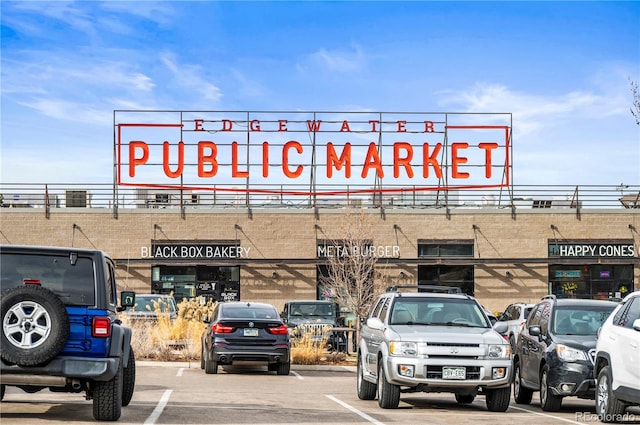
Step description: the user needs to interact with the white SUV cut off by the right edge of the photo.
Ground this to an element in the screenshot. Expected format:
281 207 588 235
594 291 640 422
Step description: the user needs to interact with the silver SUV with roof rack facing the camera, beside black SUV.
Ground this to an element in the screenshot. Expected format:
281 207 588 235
357 288 511 412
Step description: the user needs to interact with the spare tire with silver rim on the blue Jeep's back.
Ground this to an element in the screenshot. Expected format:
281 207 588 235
0 285 69 366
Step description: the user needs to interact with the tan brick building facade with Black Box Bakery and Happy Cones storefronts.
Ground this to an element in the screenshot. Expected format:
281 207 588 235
0 200 640 311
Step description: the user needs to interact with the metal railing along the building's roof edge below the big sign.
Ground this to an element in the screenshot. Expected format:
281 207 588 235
0 183 640 213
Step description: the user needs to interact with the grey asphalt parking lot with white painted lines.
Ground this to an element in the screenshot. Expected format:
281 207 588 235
0 362 640 425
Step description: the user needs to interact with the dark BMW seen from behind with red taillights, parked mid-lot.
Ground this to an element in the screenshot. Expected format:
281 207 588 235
200 301 291 375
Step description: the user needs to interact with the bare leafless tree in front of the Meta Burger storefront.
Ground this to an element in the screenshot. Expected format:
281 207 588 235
320 209 385 337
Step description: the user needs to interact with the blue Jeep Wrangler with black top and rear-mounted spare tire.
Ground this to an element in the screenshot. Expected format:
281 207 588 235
0 245 135 421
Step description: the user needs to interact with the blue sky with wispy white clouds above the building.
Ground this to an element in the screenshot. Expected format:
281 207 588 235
0 0 640 189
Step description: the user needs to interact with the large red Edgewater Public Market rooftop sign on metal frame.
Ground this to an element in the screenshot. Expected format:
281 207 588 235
114 111 511 195
